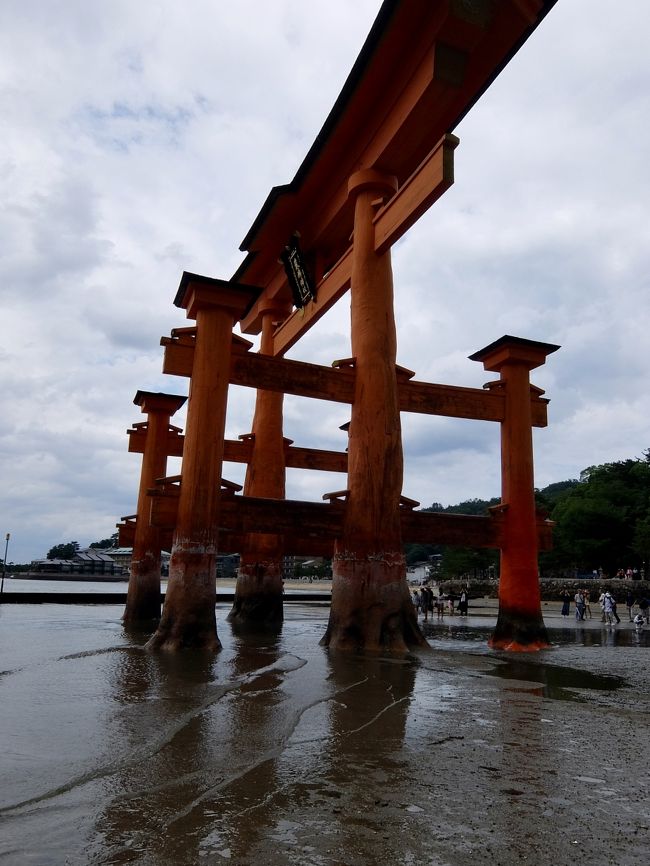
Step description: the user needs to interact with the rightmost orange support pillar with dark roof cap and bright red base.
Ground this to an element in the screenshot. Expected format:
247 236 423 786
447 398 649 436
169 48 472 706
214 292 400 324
470 336 560 652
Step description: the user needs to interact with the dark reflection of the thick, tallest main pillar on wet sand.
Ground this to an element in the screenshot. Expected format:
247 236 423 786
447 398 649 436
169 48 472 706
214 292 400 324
191 650 420 864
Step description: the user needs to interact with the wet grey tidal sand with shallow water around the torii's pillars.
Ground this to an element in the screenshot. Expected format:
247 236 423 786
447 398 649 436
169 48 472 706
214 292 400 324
0 600 650 866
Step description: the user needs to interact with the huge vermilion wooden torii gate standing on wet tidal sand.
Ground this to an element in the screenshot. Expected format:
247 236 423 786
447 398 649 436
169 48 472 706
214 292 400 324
121 0 558 651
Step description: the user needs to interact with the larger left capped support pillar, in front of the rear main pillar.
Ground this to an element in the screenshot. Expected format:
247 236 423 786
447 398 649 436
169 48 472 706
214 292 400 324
147 273 259 650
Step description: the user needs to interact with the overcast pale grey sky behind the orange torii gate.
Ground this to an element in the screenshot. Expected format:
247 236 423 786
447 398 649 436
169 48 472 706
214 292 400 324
0 0 650 562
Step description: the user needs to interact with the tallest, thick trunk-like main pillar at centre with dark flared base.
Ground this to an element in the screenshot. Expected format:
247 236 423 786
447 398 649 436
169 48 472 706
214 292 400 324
322 170 426 652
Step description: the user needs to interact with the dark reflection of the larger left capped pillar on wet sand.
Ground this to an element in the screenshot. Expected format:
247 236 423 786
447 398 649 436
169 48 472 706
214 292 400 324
90 651 223 863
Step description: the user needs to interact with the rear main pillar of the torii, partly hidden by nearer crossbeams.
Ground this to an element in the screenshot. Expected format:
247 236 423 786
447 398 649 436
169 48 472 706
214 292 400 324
228 299 290 628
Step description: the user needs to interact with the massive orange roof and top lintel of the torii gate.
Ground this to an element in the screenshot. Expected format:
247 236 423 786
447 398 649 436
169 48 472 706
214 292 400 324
232 0 557 344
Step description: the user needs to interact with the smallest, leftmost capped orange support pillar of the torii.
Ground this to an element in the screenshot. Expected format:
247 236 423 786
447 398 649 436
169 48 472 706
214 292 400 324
123 391 187 625
